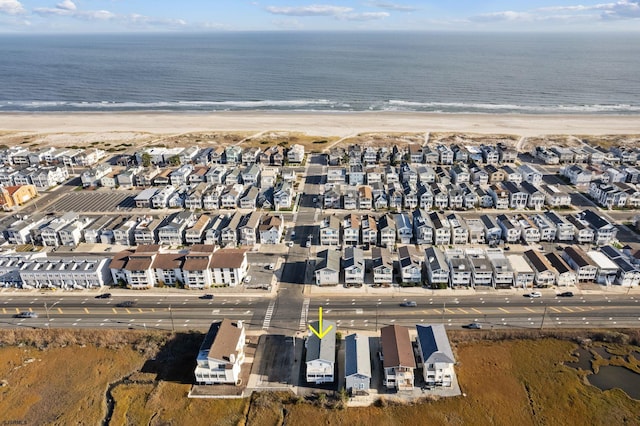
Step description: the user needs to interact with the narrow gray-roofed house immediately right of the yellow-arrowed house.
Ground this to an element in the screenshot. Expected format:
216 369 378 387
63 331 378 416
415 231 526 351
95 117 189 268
344 334 371 395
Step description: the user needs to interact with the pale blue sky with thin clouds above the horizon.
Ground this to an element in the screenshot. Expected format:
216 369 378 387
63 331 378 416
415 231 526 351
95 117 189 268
0 0 640 33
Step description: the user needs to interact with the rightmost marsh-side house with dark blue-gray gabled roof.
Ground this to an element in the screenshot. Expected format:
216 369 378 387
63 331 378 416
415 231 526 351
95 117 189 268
416 324 456 387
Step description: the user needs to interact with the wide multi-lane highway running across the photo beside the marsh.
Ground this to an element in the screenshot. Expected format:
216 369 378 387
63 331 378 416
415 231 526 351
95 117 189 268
0 294 640 335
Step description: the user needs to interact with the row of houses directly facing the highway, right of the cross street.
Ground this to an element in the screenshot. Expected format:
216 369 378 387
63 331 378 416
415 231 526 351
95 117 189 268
315 246 640 289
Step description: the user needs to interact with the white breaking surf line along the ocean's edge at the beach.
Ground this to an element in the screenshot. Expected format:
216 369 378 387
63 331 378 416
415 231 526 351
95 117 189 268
0 99 640 114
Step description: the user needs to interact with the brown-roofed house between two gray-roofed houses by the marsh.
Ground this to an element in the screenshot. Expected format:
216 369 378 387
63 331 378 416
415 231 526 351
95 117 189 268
380 324 416 391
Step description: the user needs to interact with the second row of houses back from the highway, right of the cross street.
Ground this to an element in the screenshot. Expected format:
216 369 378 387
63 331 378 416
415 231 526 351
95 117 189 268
319 209 617 247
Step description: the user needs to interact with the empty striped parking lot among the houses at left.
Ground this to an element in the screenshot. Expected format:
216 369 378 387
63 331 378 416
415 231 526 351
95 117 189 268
46 190 139 213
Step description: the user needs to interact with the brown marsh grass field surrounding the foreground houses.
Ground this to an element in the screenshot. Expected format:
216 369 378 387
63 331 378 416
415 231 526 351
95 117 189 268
0 330 640 426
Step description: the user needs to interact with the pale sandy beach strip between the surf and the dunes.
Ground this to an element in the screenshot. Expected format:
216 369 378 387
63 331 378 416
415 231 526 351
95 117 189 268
0 111 640 137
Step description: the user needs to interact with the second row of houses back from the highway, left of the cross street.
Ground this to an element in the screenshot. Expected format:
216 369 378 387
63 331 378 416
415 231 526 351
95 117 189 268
4 211 284 247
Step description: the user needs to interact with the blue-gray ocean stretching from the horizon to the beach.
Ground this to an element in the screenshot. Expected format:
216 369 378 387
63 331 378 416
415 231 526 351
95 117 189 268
0 32 640 114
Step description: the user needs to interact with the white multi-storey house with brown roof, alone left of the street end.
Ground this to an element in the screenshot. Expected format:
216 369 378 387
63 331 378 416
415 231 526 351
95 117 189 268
194 318 246 385
